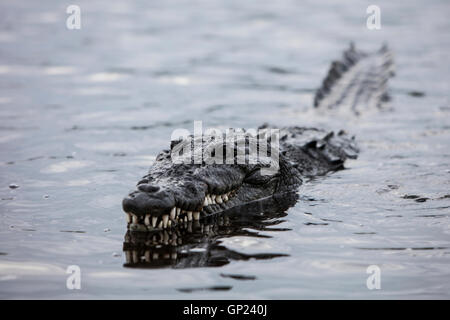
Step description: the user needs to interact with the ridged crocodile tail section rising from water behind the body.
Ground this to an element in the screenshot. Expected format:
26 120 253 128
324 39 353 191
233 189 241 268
314 44 394 114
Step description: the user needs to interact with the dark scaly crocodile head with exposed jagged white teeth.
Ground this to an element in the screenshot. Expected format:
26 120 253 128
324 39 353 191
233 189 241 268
122 129 301 231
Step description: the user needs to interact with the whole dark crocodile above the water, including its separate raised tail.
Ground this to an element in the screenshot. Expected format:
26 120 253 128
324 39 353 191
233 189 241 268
122 44 394 232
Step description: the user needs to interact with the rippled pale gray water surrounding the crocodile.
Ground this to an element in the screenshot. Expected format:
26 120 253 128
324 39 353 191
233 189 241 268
0 0 450 299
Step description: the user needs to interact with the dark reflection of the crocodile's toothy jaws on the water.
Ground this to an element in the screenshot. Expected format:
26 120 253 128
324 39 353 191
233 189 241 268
123 193 298 269
